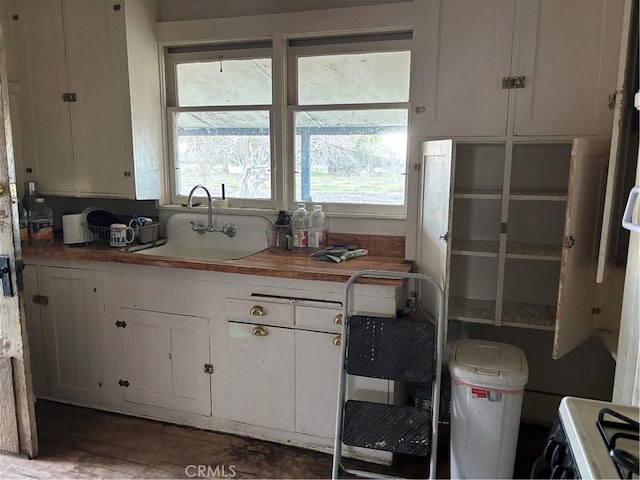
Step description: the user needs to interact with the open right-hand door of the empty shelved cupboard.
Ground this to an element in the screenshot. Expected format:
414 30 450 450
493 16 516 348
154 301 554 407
552 138 609 359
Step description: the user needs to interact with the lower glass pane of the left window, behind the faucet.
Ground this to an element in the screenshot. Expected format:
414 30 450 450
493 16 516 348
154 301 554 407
174 111 271 199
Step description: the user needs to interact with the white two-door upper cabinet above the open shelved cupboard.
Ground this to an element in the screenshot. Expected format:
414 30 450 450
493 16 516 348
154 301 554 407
411 0 624 137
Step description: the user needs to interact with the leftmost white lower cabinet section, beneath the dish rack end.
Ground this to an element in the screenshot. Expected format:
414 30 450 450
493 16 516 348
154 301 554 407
25 265 101 404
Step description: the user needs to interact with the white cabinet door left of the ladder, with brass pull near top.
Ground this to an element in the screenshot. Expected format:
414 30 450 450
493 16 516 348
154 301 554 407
229 322 295 432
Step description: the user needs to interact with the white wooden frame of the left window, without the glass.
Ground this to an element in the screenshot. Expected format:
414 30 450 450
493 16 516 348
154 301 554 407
164 45 278 210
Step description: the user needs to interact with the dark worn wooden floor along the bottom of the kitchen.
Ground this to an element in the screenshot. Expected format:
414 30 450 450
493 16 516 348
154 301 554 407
0 400 549 479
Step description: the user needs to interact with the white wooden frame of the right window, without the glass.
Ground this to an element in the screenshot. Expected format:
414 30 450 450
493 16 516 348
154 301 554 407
283 36 413 216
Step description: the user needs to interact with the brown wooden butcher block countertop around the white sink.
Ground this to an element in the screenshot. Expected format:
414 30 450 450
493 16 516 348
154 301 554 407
23 241 413 287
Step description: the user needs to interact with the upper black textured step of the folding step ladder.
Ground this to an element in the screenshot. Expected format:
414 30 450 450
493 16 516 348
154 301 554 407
346 315 436 383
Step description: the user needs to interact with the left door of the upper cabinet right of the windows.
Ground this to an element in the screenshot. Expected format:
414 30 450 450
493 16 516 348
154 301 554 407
412 0 514 136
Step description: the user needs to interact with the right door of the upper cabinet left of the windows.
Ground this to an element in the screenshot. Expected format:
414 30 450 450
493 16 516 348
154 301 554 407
64 0 133 196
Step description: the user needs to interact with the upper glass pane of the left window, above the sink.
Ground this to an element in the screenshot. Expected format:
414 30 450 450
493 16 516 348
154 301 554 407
176 58 271 107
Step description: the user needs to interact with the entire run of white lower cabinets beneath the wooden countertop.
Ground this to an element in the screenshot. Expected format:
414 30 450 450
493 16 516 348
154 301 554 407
24 259 399 463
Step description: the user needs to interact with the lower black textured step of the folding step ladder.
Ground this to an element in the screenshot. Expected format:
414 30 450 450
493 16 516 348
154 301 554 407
342 400 431 456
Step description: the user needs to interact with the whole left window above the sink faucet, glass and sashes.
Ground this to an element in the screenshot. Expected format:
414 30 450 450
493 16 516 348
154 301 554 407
167 44 273 206
